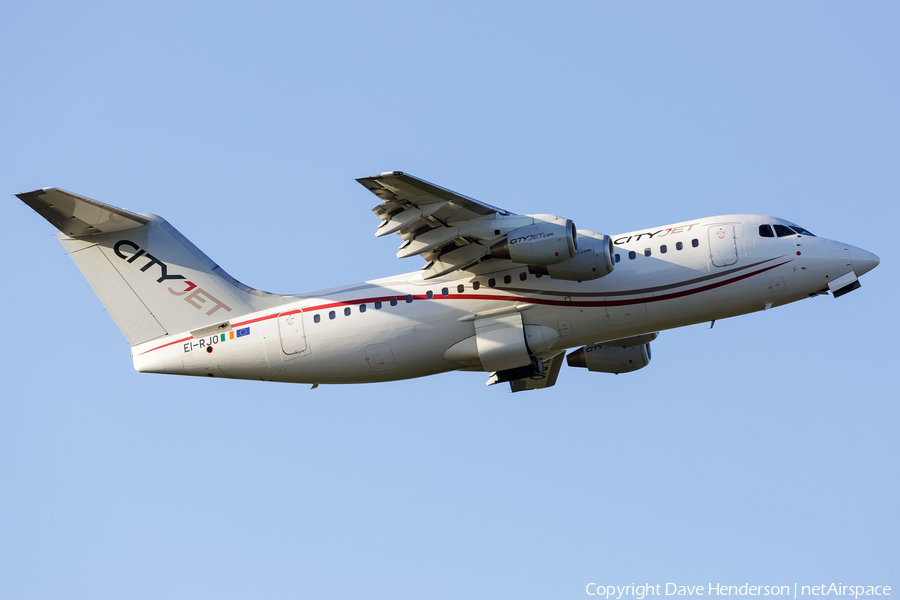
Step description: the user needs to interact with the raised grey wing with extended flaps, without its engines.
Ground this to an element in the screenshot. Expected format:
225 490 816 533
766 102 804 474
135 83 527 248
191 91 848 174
357 171 513 279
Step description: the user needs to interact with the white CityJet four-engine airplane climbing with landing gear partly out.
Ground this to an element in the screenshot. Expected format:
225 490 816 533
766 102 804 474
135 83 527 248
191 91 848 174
17 171 879 392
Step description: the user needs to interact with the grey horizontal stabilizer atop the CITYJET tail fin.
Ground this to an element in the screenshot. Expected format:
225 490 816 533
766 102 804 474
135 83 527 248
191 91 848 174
16 188 150 237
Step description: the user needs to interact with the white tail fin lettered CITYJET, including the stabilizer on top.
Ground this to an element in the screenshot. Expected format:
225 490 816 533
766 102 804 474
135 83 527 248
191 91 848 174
18 188 281 346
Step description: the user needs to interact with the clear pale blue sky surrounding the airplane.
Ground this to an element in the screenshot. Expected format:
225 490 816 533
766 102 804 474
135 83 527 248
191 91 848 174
0 1 900 599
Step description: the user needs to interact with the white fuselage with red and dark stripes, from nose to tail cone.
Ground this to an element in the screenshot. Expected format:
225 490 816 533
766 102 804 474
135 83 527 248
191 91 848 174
133 215 877 384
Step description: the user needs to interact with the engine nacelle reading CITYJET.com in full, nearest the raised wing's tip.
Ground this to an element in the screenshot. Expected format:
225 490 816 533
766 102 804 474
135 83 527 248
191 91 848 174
491 217 578 266
